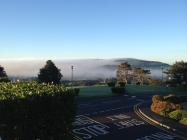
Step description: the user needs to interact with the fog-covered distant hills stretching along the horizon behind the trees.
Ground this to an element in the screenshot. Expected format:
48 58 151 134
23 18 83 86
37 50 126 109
0 58 169 80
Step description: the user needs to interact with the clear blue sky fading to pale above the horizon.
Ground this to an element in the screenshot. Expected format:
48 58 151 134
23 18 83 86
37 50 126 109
0 0 187 63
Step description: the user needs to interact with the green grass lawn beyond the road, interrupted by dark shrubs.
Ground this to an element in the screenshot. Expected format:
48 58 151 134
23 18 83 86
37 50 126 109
79 85 186 98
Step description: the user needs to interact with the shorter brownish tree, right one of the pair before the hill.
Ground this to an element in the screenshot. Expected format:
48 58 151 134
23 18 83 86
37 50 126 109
132 68 150 85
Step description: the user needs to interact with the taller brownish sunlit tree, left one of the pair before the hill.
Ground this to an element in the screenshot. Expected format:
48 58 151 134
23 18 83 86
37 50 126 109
117 62 131 84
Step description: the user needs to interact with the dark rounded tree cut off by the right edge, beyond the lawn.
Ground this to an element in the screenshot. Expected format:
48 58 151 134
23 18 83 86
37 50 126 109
165 61 187 87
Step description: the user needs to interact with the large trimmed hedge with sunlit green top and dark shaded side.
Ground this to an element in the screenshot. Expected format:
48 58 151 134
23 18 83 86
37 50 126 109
0 82 76 140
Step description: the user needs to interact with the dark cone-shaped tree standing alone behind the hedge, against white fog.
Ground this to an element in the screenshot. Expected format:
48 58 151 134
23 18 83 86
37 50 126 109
38 60 63 84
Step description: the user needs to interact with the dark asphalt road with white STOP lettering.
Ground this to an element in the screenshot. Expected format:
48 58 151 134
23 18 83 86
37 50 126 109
73 95 185 140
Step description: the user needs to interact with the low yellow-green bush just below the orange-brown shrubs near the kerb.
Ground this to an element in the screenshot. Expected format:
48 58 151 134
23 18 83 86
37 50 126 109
169 110 187 121
